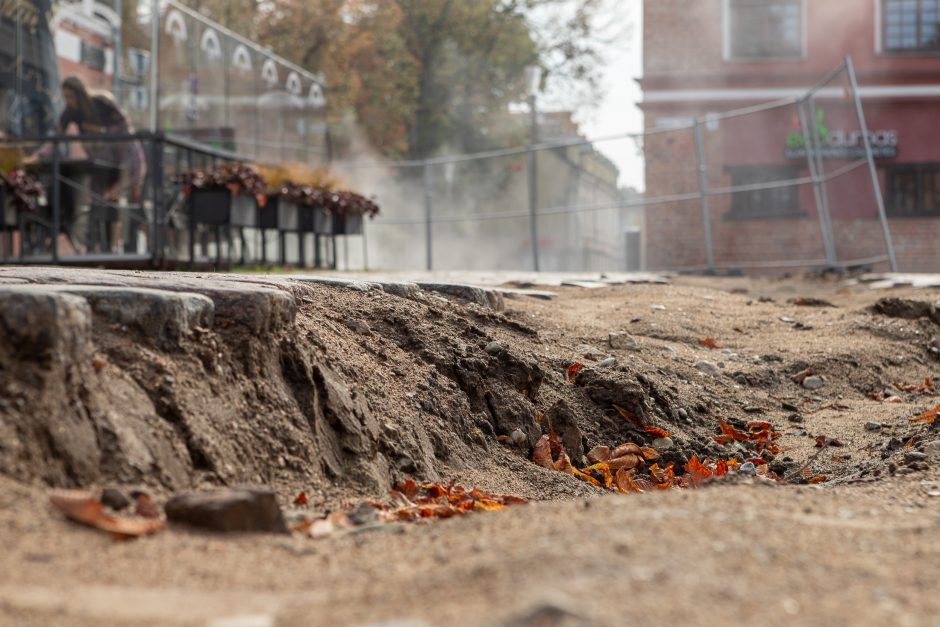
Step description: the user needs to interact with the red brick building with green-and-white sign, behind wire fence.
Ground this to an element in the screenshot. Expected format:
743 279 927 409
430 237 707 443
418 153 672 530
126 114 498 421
641 0 940 271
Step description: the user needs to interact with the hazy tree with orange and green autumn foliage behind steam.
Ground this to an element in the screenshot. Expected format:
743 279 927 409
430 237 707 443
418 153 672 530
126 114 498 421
181 0 607 159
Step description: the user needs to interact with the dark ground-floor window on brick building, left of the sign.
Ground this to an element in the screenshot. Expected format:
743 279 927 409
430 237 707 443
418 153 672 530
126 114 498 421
728 166 800 219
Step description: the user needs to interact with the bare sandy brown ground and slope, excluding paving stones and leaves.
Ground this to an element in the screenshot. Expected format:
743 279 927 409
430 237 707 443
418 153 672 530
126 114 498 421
0 278 940 626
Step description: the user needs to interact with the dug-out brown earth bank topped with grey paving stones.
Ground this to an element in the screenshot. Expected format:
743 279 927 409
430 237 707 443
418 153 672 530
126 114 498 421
0 268 929 505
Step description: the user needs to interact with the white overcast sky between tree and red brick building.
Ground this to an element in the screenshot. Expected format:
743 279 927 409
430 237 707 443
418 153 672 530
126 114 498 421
577 0 643 189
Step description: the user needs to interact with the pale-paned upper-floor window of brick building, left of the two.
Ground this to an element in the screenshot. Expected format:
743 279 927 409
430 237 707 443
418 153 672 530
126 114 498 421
727 0 803 59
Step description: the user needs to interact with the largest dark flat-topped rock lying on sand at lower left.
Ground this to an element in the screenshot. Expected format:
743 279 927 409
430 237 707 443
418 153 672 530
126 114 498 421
165 488 287 533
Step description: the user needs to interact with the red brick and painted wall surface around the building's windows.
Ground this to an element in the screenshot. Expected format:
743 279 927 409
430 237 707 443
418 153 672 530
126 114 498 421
643 0 940 271
